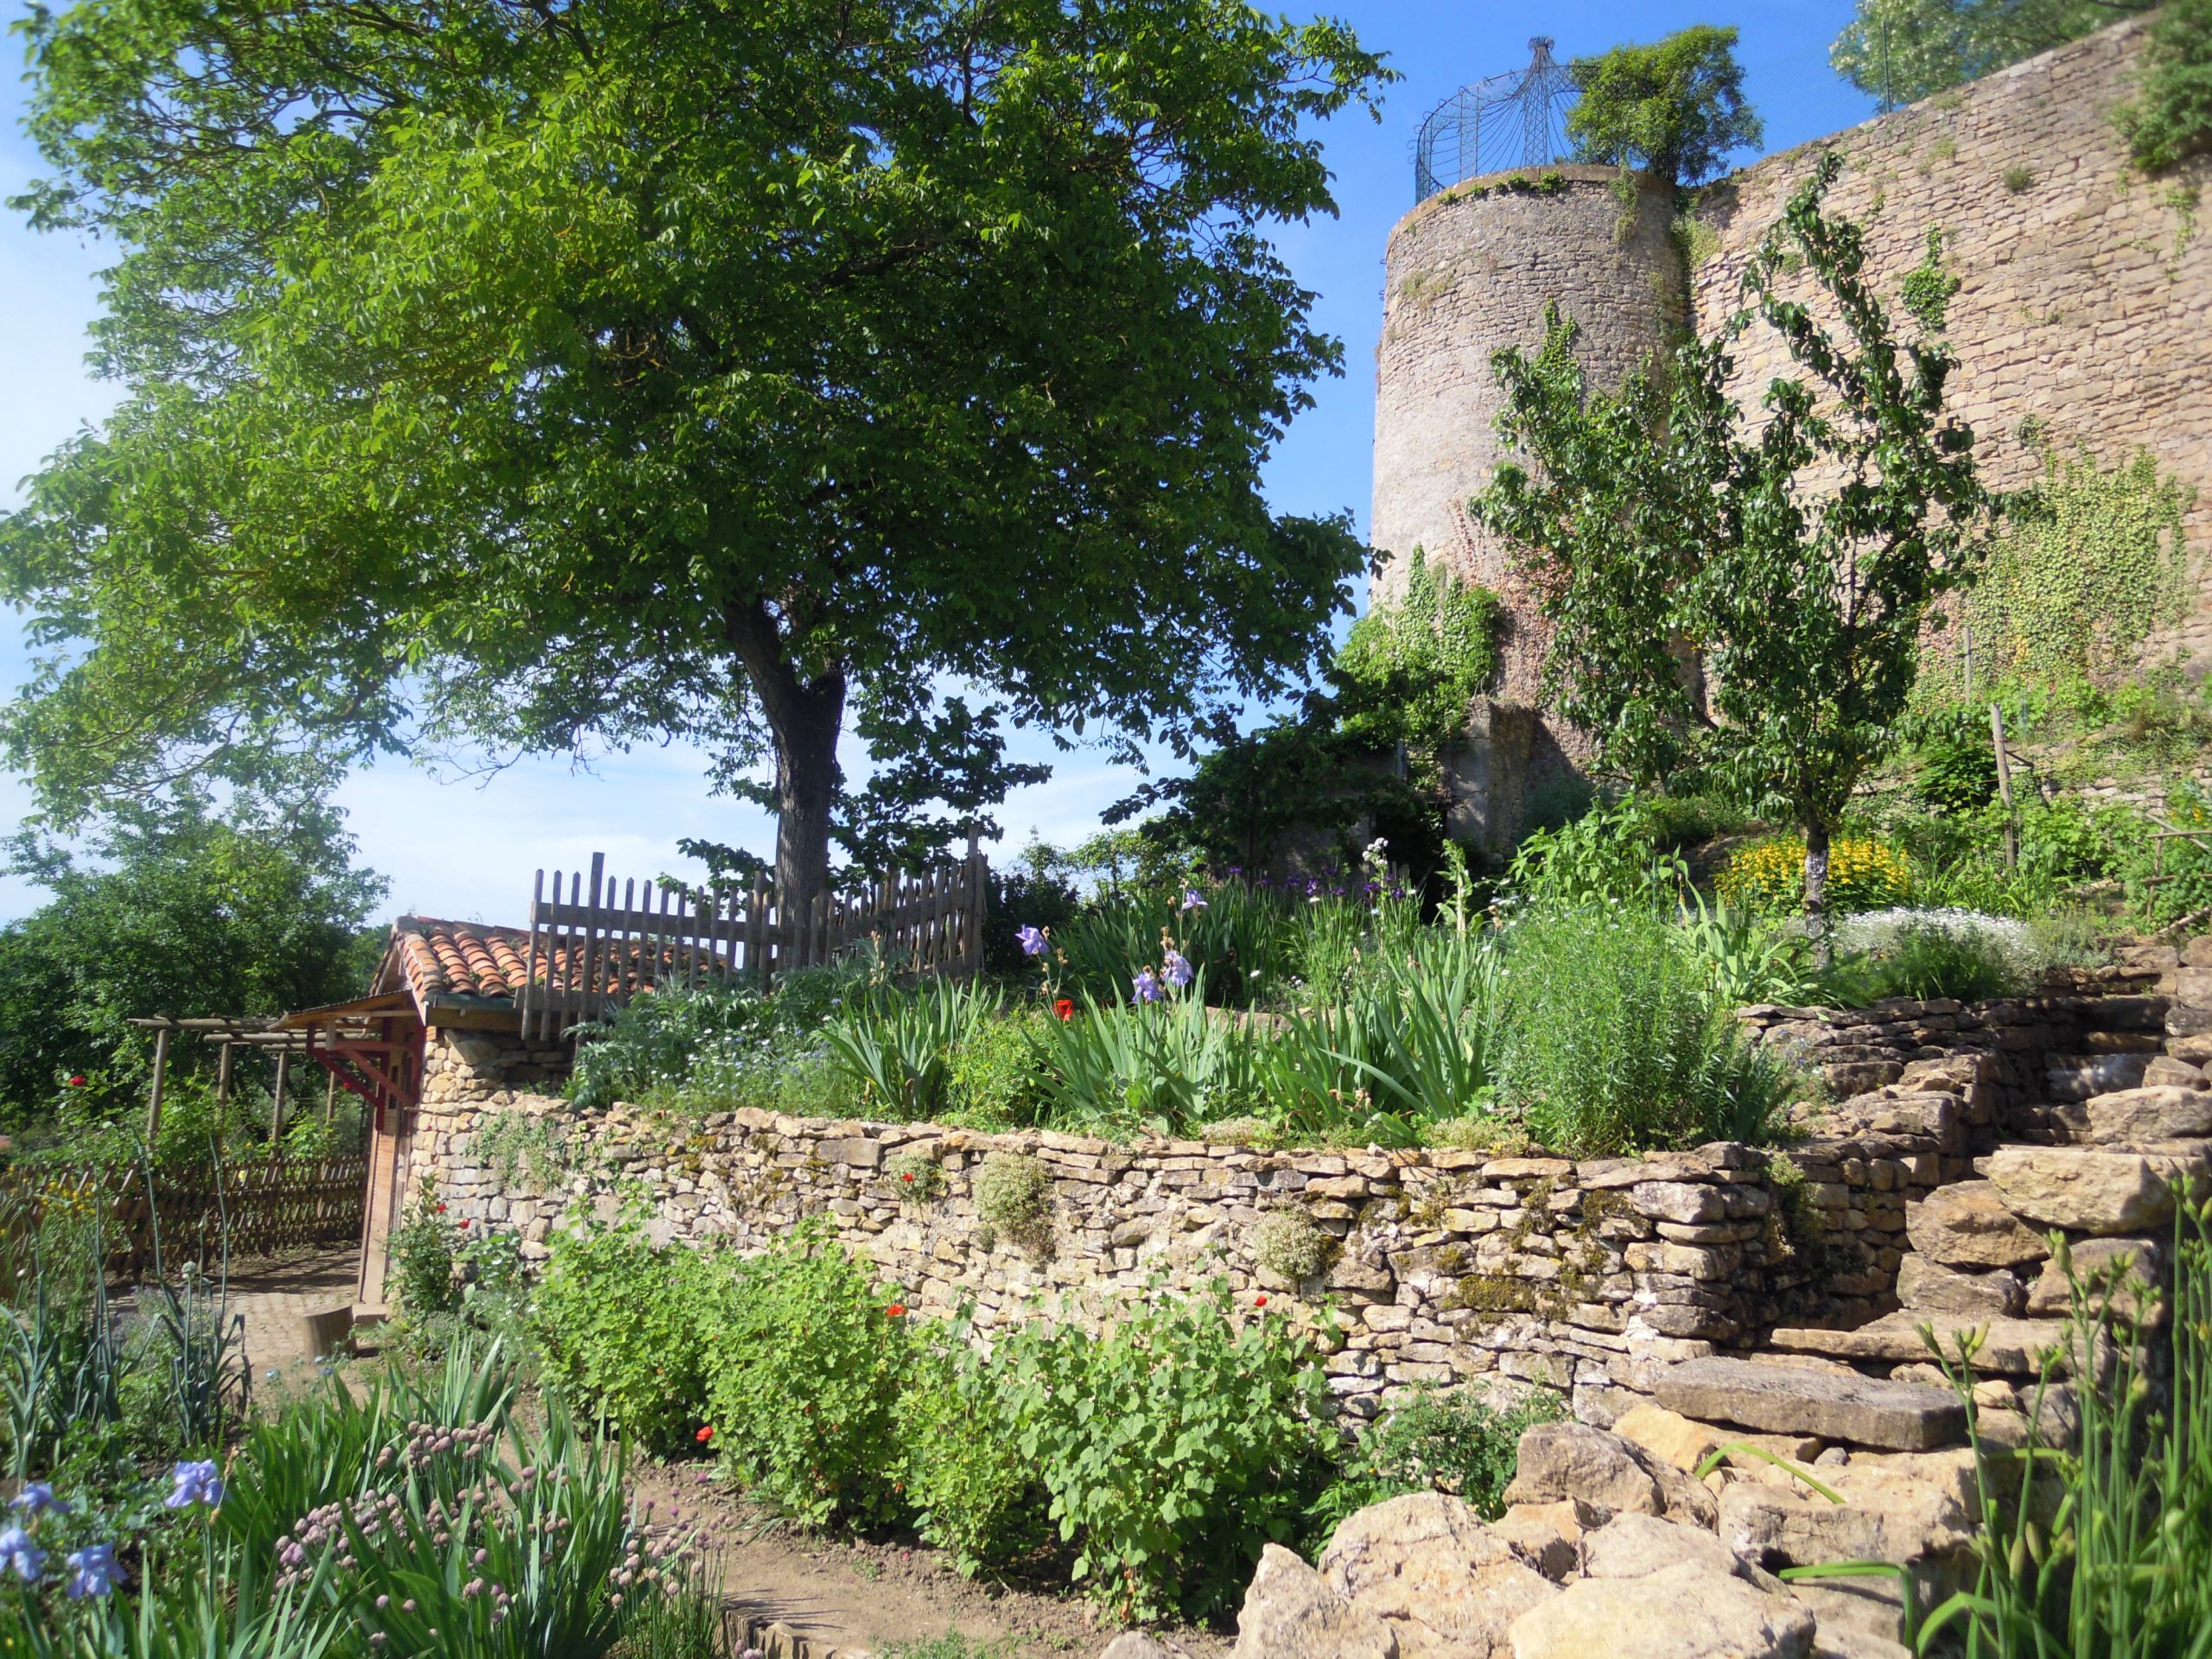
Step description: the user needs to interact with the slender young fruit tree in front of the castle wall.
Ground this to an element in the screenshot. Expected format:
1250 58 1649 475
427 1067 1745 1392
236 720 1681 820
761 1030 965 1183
1471 153 1988 949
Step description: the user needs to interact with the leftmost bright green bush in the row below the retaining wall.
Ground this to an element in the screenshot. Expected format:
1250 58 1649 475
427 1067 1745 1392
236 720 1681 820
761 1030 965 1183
531 1219 716 1455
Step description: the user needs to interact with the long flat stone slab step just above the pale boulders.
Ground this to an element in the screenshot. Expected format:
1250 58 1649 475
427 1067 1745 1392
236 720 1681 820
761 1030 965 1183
1656 1356 1967 1451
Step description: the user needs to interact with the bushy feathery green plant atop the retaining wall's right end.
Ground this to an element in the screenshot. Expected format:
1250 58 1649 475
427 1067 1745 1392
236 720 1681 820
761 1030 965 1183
1497 907 1796 1157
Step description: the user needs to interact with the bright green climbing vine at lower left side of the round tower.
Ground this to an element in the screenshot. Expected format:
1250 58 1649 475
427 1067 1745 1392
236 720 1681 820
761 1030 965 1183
1330 549 1504 766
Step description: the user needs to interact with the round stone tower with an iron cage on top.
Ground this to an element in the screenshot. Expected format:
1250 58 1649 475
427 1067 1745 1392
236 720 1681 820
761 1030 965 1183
1370 166 1686 845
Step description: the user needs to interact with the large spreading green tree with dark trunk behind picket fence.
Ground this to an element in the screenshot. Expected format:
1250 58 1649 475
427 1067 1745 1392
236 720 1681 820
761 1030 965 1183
0 0 1385 898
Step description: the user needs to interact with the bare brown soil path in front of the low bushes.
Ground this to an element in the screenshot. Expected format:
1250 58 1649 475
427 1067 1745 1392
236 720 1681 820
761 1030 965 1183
632 1465 1232 1659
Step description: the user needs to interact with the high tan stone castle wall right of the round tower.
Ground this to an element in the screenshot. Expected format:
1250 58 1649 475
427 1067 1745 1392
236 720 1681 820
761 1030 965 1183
1690 20 2212 661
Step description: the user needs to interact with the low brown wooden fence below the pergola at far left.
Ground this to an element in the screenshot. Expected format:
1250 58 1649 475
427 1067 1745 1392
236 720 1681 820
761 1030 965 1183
0 1154 370 1276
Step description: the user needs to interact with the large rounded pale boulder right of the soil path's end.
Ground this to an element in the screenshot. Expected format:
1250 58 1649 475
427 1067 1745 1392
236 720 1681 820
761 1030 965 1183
1320 1493 1560 1659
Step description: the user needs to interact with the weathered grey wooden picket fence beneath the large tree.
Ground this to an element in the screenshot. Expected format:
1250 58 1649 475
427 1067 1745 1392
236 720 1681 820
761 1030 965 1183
522 849 988 1042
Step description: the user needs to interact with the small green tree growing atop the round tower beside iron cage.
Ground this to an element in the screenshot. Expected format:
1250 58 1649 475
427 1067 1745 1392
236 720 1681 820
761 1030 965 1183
1566 22 1765 186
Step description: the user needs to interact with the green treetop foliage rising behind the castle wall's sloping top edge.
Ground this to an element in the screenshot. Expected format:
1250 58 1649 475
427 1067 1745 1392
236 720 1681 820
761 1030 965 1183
1827 0 2154 108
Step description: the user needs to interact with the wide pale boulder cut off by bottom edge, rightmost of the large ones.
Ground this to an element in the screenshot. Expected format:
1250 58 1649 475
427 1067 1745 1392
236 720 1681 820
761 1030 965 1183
1513 1564 1814 1659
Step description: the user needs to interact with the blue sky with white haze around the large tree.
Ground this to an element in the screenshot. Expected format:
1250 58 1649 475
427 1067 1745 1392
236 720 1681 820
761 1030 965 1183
0 0 1873 920
